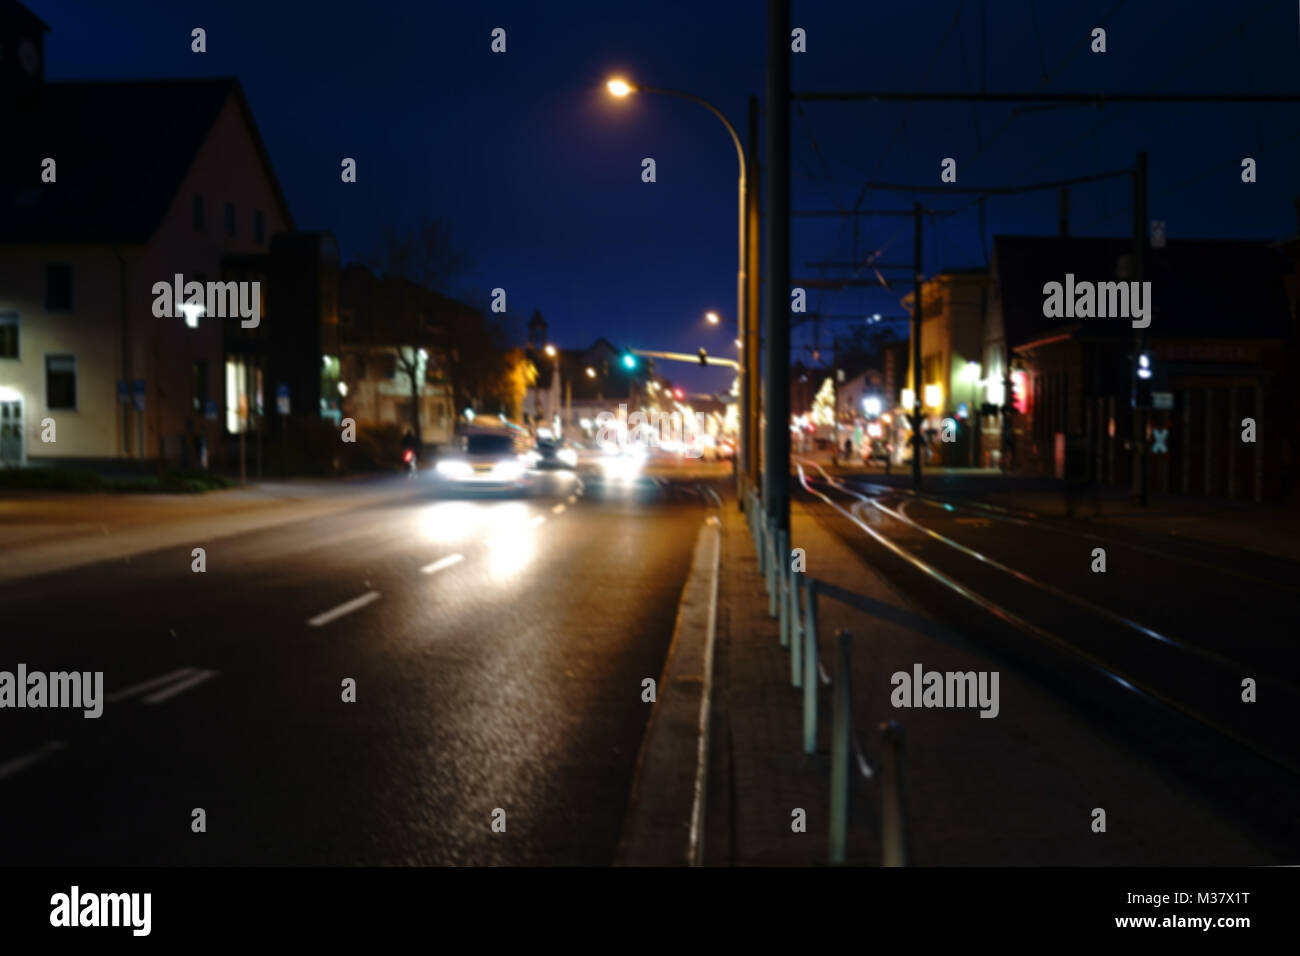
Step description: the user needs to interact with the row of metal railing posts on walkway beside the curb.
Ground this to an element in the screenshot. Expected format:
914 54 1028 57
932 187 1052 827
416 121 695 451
745 490 909 866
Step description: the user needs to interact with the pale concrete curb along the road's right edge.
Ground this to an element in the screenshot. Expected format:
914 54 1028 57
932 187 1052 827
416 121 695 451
614 516 722 866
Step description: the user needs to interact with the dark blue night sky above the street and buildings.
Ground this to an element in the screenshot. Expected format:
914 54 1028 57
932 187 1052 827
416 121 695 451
29 0 1300 389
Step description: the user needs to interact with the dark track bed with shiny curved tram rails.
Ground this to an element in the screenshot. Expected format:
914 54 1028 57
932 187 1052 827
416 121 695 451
801 468 1300 851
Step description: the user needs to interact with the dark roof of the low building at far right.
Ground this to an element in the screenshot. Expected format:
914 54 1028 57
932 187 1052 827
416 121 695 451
993 235 1292 347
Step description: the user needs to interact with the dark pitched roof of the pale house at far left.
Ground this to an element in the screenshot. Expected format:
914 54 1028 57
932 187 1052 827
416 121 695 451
0 77 293 243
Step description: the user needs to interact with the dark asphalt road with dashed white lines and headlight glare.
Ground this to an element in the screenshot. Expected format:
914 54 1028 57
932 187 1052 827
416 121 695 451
0 468 709 865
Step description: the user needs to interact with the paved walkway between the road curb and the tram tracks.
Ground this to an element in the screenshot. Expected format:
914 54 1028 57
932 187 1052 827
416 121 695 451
705 501 1282 865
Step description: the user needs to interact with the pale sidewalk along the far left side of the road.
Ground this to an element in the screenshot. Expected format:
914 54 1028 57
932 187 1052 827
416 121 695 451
0 476 426 583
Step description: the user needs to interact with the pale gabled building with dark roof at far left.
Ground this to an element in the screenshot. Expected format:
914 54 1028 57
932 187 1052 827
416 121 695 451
0 3 297 464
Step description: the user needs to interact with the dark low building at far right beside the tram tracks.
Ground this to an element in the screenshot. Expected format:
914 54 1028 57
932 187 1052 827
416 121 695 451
984 237 1297 501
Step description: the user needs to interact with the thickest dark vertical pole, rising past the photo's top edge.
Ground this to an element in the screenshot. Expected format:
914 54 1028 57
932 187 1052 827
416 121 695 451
763 0 790 531
